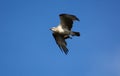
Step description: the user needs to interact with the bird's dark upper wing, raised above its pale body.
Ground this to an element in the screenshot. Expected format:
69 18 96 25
59 14 79 30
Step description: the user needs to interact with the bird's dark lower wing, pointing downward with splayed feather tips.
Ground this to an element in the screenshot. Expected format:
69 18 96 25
52 33 69 54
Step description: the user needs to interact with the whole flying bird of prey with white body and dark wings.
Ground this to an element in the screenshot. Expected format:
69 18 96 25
50 14 80 54
